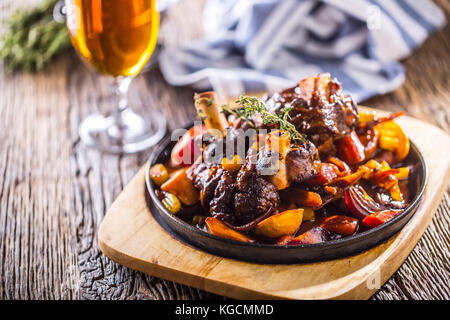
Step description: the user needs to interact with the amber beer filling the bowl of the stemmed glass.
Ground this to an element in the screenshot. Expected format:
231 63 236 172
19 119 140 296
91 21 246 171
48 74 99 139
66 0 159 77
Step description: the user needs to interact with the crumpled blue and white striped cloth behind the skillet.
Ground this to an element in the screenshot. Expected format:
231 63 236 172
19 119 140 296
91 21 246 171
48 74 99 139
160 0 446 101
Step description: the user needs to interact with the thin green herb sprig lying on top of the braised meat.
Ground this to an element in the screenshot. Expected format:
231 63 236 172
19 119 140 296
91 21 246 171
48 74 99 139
234 95 305 142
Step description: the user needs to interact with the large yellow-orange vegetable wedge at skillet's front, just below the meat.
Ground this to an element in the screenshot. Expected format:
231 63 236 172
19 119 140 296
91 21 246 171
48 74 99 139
255 209 303 238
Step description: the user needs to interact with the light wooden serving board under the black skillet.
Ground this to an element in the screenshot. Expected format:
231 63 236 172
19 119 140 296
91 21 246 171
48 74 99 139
98 110 450 299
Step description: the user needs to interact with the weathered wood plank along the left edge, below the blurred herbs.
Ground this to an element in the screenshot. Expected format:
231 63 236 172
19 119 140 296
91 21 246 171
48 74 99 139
0 58 76 299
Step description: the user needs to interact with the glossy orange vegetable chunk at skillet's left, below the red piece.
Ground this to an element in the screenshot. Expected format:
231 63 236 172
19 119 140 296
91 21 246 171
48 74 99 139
161 168 200 206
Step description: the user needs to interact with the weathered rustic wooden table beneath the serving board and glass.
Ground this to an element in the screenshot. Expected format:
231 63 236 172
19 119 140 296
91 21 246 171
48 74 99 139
0 0 450 300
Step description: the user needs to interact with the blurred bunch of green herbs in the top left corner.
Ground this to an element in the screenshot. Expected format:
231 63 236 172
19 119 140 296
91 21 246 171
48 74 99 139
0 0 70 73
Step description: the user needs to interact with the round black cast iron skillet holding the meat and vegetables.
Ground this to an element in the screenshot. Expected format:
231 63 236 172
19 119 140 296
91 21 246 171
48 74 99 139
146 129 427 264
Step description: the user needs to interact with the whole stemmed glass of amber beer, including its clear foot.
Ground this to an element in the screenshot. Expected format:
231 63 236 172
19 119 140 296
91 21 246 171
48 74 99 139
65 0 166 153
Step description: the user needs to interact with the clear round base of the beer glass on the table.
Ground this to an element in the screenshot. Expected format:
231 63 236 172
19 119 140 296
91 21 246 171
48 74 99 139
79 108 167 154
